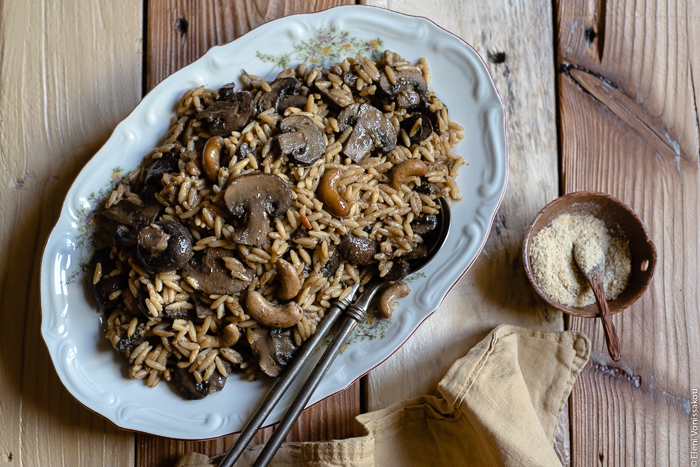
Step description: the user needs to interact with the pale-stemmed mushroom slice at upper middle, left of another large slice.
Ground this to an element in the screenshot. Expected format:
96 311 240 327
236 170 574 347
275 115 326 165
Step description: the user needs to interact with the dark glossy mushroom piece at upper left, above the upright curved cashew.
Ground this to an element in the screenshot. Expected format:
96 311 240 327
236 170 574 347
199 91 254 137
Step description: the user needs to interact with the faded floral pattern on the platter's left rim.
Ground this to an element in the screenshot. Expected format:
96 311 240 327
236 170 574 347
66 167 124 285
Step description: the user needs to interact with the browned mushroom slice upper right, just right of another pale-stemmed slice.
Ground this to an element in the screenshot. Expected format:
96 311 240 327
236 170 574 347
338 104 396 162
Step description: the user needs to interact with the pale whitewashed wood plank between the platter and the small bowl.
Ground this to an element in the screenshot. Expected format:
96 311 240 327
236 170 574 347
358 0 566 458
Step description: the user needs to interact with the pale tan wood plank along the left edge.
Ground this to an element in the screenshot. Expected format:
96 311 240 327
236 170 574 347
0 0 142 467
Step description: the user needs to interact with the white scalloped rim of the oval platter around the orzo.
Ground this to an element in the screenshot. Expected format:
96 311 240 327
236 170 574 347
41 5 508 439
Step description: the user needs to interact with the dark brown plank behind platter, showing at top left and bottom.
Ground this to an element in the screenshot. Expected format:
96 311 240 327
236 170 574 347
136 0 360 466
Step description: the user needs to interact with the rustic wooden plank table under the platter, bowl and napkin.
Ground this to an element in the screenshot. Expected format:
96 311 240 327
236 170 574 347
0 0 700 467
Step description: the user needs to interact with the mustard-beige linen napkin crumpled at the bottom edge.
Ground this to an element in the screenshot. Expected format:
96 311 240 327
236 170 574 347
176 326 590 467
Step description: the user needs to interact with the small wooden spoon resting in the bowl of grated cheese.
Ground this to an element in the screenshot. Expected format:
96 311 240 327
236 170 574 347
574 239 621 362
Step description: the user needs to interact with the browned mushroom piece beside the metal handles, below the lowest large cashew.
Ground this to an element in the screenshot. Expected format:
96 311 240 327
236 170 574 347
247 326 297 378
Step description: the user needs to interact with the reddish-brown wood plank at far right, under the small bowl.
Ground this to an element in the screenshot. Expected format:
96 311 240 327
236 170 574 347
557 0 700 466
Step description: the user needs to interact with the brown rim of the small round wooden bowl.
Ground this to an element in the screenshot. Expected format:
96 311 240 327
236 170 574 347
522 191 656 318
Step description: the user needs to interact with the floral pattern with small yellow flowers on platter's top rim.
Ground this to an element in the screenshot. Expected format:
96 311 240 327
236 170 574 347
255 27 383 68
